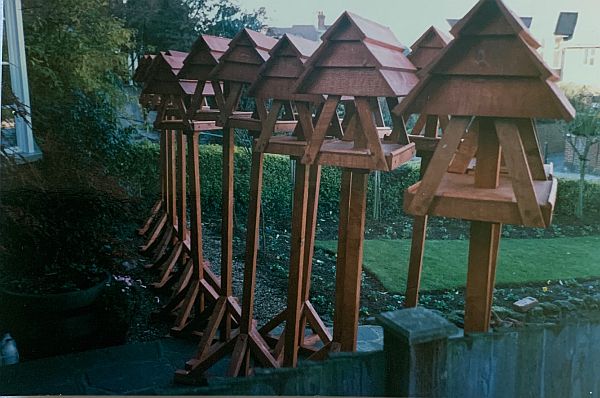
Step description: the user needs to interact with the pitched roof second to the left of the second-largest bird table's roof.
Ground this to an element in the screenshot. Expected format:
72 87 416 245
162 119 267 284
209 29 277 83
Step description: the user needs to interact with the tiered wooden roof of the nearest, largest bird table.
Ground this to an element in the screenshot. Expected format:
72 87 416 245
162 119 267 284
394 0 575 120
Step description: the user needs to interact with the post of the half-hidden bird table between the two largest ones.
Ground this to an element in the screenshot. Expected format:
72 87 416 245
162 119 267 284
404 216 428 308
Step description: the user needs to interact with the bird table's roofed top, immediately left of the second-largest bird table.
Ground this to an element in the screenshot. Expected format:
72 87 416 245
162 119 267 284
249 34 326 156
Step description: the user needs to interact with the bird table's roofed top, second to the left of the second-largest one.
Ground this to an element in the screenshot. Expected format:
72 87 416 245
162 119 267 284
209 29 277 131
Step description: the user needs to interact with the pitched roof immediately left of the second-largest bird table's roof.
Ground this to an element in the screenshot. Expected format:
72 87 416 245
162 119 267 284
249 34 323 102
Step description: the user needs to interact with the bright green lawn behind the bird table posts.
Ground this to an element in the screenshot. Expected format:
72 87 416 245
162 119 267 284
317 236 600 292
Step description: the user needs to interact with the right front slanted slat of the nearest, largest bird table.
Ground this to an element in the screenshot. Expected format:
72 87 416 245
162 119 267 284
494 120 544 226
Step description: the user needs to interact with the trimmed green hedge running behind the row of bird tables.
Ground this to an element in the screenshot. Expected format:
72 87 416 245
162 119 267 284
127 143 600 223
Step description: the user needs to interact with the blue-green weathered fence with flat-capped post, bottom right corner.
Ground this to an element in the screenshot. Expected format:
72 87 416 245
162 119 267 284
381 308 600 397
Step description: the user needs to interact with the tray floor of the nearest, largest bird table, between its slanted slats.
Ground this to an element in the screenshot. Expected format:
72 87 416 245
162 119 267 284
404 173 558 227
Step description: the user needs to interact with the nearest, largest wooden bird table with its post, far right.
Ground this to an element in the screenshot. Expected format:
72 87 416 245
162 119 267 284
394 0 574 331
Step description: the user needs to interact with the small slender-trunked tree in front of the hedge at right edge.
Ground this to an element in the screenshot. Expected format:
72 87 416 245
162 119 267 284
566 88 600 218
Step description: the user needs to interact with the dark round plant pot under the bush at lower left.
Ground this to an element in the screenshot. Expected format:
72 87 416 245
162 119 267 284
0 274 118 360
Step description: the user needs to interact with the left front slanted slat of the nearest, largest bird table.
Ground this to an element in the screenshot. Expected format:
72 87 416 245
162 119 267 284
408 116 469 216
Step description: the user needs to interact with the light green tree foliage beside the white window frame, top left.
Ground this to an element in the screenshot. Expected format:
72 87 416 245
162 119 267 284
23 0 132 102
